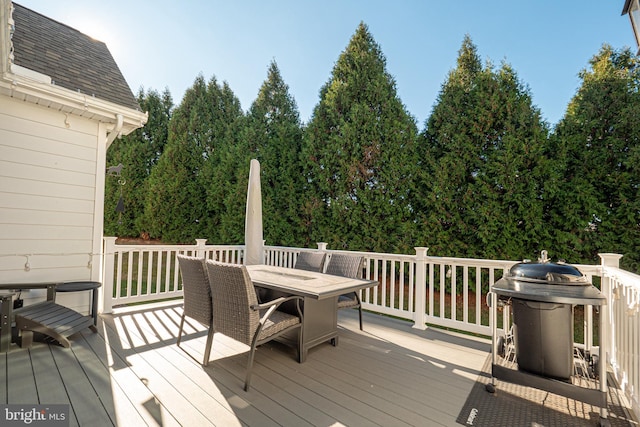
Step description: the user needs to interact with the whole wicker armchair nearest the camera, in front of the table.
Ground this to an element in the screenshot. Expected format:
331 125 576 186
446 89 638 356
206 260 302 391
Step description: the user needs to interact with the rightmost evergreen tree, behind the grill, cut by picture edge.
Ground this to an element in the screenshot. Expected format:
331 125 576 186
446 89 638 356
548 45 640 271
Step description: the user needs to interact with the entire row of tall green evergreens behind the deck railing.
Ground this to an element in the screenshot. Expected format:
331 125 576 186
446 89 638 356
105 23 640 271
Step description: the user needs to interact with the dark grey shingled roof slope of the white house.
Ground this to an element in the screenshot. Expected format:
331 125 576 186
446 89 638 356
12 3 140 110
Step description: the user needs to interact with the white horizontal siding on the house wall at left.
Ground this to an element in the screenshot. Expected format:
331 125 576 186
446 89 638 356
0 96 106 311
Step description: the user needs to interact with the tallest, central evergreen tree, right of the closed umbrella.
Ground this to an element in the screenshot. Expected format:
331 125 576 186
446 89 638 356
301 23 417 252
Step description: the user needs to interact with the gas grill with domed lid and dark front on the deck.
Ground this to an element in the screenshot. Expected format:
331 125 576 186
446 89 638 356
487 251 609 425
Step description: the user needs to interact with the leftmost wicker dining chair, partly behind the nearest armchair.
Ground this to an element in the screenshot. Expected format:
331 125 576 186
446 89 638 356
176 255 214 366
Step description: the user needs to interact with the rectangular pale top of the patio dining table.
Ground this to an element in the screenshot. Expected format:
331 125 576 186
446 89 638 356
247 265 378 299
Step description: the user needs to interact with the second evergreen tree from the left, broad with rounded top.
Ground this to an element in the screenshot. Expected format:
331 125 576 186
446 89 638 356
145 76 242 243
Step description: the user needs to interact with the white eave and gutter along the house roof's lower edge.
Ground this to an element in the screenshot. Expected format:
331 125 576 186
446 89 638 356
0 65 148 135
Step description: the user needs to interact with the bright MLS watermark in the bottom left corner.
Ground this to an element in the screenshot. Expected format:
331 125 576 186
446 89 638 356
0 404 69 427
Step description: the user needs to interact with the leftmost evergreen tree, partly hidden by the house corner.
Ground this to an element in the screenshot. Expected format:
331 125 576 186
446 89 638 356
104 89 173 237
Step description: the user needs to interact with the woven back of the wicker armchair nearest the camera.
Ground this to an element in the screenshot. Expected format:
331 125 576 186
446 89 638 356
206 260 260 345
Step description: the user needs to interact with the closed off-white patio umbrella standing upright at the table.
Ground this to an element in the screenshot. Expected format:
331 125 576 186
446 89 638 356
244 159 264 265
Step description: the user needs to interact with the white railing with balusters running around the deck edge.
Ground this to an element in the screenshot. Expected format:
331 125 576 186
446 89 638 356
102 237 640 422
